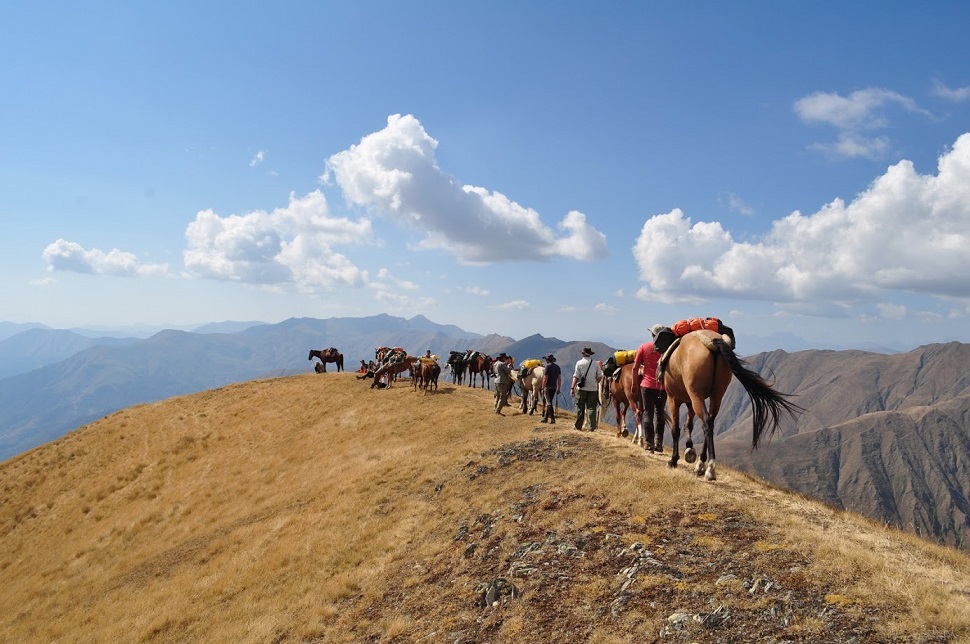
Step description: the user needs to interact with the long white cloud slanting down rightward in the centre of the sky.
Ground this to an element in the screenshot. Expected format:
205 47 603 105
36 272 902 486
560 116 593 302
323 114 606 264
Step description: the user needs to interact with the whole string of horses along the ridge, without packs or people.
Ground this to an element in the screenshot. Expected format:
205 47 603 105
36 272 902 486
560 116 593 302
310 329 803 481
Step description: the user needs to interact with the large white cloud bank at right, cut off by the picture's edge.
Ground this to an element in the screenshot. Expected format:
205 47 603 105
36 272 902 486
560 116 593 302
633 134 970 307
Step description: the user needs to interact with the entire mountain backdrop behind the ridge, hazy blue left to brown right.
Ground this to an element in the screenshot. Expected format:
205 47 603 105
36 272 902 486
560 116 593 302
0 315 970 547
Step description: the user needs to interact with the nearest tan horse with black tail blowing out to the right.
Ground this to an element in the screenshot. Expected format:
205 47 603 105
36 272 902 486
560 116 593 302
663 330 804 481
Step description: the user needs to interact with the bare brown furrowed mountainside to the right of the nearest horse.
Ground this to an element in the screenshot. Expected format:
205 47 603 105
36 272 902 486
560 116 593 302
697 342 970 549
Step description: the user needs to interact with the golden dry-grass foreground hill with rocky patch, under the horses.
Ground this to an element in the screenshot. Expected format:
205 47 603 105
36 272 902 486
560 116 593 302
0 373 970 642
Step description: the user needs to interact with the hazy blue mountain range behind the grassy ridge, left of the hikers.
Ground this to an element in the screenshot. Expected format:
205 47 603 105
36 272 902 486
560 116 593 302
0 315 609 460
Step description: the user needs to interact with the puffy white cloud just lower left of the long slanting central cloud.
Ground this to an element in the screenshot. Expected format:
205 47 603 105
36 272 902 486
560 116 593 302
182 191 371 292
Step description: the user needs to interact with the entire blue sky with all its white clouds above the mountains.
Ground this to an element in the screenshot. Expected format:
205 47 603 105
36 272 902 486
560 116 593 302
0 1 970 352
